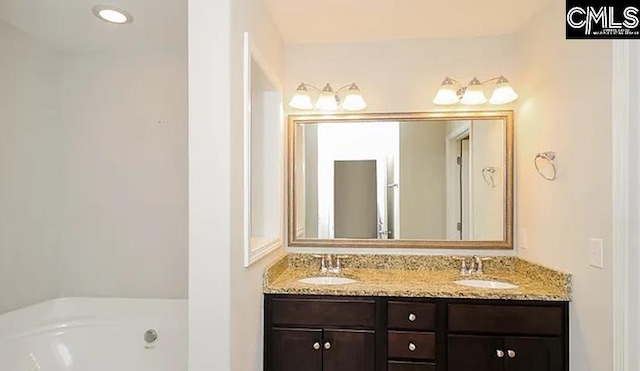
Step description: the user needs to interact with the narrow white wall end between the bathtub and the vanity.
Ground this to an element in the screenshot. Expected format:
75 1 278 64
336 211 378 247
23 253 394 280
189 0 232 371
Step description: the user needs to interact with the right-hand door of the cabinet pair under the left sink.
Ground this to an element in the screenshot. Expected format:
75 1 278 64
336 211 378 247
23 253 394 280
323 330 376 371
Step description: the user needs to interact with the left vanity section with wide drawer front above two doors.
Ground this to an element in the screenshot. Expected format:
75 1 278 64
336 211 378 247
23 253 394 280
265 296 377 371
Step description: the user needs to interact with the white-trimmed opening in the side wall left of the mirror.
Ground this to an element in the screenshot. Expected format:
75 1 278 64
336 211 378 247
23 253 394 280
244 35 283 267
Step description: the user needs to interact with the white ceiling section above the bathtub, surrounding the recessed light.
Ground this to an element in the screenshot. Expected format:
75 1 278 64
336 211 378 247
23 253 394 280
0 0 187 51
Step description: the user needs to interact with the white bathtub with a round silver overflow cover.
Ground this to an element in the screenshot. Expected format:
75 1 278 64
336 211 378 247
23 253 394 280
0 298 187 371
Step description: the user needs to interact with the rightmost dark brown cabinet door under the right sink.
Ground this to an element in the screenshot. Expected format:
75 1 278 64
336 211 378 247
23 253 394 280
504 337 563 371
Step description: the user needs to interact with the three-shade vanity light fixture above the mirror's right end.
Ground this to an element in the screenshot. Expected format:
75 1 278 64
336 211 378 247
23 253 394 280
433 75 518 105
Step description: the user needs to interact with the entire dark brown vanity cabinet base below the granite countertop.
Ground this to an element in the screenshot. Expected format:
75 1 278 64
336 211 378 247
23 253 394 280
264 295 569 371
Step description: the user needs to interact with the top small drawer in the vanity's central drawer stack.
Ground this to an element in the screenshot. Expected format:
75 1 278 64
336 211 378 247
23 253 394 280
387 301 436 331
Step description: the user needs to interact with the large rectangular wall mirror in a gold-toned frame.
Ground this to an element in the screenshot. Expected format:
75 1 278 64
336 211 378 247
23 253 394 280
288 111 513 249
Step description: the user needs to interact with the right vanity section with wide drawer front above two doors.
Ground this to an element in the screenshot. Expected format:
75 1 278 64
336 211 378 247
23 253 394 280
447 303 568 371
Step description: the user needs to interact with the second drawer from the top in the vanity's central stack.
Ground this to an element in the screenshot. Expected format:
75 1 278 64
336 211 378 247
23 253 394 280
388 331 436 360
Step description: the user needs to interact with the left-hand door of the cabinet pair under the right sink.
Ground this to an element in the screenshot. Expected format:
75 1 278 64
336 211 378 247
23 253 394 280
447 335 504 371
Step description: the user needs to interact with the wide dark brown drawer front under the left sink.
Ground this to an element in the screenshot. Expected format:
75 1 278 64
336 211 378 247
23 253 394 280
271 298 376 328
